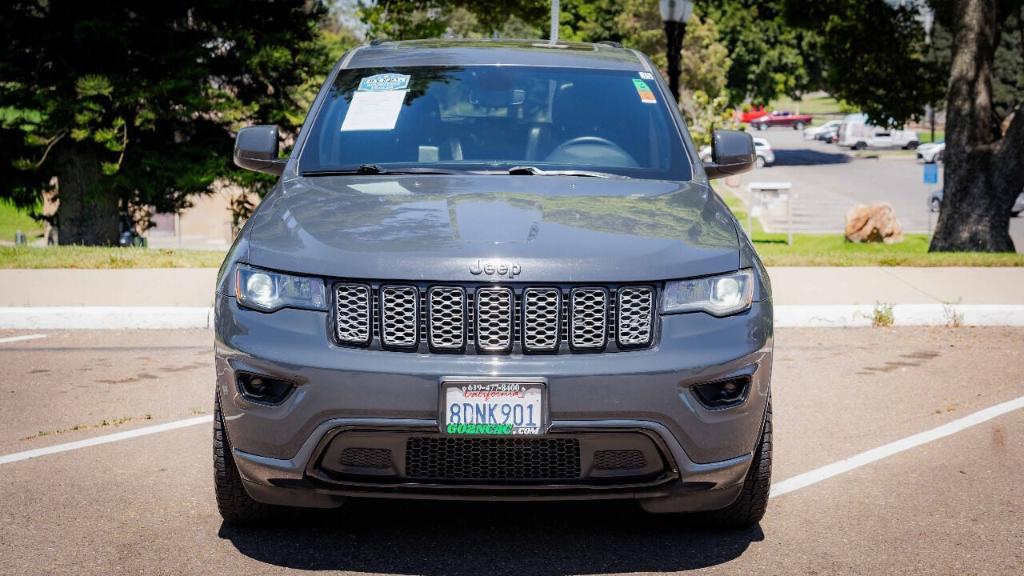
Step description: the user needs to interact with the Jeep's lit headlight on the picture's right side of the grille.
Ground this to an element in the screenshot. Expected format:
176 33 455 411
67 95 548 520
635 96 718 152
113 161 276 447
662 270 754 316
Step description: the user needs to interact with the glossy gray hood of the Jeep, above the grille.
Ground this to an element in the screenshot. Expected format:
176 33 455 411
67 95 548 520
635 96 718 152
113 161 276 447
247 175 739 282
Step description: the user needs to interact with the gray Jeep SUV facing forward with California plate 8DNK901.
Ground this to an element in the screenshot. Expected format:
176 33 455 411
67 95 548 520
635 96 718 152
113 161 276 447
214 40 772 526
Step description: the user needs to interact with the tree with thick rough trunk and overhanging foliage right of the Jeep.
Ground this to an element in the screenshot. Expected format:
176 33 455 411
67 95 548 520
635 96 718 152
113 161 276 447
790 0 1024 252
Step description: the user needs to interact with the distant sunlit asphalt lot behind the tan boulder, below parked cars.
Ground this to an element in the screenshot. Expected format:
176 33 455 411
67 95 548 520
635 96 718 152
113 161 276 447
739 128 1024 251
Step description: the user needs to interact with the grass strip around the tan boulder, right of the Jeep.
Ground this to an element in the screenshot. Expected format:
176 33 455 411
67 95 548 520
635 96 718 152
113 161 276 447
720 187 1024 266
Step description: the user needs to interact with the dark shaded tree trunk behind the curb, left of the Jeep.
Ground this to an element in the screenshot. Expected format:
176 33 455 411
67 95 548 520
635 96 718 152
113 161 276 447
56 142 120 246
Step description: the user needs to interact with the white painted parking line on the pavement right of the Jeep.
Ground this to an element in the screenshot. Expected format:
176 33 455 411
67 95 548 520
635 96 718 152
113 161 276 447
769 396 1024 498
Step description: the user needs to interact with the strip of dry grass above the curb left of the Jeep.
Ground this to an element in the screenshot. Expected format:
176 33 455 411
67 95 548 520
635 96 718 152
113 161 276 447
0 246 224 269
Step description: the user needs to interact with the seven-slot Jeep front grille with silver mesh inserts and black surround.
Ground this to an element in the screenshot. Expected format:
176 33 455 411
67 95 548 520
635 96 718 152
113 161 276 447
333 282 657 354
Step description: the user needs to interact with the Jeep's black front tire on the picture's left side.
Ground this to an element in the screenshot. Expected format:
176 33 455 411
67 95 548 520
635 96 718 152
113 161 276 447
213 397 278 524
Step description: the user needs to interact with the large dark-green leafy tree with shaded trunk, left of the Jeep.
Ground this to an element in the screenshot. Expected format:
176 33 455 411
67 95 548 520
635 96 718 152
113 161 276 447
0 0 329 244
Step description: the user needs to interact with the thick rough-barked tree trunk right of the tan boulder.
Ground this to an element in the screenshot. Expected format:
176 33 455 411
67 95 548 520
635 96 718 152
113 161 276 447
929 0 1024 252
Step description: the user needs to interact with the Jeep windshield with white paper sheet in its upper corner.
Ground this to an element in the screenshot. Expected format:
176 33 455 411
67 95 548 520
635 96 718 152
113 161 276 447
299 67 691 180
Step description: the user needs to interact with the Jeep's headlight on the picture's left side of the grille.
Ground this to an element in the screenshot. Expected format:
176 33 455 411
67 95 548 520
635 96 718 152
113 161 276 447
234 264 327 312
